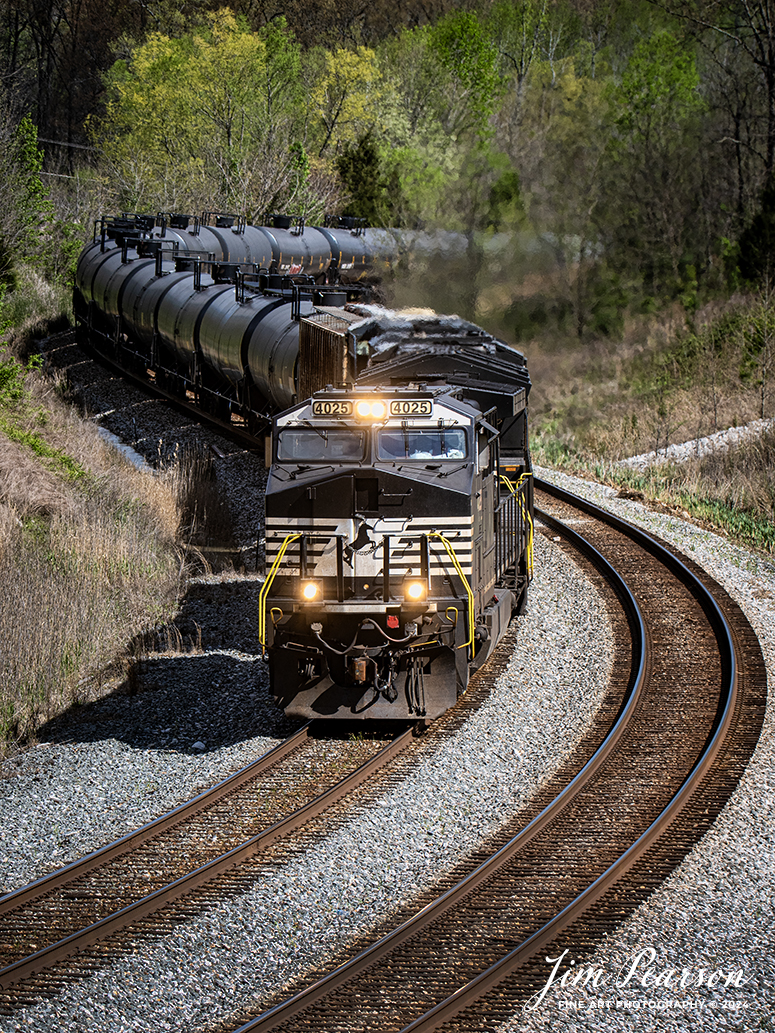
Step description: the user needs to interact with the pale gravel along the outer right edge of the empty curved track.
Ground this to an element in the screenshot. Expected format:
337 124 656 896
499 470 775 1033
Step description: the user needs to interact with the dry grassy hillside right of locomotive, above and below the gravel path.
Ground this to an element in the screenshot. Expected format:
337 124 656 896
530 298 775 552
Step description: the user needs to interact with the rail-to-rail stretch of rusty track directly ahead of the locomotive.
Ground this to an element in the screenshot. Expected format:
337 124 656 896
0 724 412 1013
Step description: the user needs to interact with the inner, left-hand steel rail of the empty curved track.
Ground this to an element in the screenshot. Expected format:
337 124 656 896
230 513 649 1033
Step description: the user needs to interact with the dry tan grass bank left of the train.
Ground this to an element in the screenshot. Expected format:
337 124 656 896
0 342 221 755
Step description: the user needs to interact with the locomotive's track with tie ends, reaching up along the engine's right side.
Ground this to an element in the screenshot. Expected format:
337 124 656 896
0 619 522 1014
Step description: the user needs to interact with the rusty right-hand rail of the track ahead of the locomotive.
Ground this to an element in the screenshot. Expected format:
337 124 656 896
0 726 414 990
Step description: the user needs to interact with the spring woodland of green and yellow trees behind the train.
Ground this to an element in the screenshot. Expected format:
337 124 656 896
0 0 775 332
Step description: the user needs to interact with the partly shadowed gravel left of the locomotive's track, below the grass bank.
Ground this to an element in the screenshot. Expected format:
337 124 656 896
0 651 287 893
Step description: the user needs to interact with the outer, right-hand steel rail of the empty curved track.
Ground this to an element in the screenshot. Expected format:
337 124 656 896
394 480 738 1033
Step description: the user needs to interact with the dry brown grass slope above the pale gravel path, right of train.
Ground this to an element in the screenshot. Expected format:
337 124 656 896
525 298 775 461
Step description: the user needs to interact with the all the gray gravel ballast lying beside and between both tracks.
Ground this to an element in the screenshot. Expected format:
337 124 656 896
0 340 775 1033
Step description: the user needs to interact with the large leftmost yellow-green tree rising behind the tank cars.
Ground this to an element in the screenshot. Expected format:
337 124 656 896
93 11 305 219
